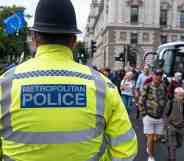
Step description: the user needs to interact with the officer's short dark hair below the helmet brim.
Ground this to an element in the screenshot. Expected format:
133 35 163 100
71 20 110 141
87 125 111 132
35 32 76 46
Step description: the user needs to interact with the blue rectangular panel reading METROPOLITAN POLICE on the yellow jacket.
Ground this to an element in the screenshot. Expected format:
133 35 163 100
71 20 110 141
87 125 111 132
22 85 86 107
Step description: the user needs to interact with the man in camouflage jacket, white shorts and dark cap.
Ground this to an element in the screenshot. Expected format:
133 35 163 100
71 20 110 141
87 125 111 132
139 69 167 161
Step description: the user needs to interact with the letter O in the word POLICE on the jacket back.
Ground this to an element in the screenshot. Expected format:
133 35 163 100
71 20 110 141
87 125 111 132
33 93 47 106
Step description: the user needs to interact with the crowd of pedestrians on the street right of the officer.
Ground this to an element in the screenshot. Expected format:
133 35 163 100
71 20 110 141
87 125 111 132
97 65 184 161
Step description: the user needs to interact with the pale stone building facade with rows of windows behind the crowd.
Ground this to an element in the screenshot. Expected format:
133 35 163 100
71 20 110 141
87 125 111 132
85 0 184 69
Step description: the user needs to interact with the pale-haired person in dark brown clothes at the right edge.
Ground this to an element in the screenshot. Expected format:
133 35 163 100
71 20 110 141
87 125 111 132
164 87 184 161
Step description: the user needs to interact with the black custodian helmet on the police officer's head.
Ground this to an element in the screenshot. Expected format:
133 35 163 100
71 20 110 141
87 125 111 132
30 0 81 34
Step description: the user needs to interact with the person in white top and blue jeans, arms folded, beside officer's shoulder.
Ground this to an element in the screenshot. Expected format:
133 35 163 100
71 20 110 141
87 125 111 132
120 72 135 112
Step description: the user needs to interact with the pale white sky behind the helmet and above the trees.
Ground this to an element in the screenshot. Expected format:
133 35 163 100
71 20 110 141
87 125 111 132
0 0 91 39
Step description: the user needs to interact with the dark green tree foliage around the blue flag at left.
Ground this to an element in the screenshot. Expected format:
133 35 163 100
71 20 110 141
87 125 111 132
0 5 30 71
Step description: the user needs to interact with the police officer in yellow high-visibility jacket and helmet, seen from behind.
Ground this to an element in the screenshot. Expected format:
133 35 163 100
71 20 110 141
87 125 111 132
0 0 137 161
